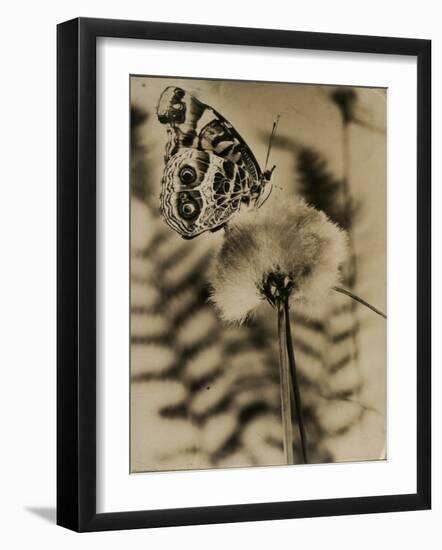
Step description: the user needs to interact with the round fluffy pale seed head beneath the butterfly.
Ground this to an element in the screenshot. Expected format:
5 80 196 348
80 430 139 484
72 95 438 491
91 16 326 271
211 200 347 322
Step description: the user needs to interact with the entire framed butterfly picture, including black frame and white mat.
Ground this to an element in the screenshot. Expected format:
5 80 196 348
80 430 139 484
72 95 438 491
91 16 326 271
57 18 431 531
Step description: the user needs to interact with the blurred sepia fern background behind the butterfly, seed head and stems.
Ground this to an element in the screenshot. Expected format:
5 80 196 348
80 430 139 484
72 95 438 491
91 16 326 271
130 76 387 472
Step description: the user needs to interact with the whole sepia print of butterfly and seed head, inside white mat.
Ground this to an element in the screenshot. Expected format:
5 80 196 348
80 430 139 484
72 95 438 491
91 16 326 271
130 76 387 473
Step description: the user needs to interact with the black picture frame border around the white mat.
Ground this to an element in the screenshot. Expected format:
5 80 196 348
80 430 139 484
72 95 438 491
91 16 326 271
57 18 431 531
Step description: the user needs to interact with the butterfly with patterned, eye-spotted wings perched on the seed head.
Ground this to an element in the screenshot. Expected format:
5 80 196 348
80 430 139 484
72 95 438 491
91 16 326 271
157 86 276 239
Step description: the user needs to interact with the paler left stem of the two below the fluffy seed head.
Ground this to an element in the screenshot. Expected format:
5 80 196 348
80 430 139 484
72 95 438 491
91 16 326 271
277 300 294 464
